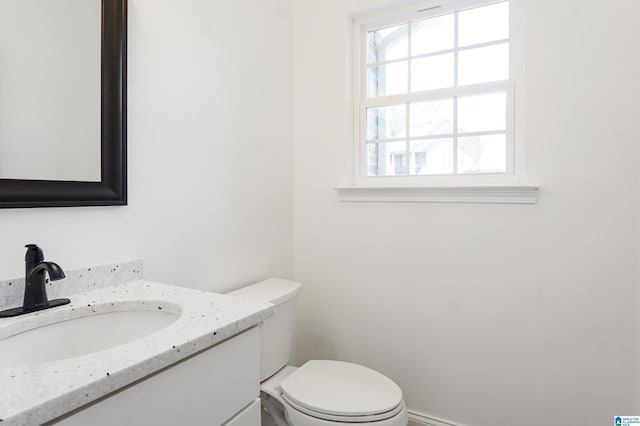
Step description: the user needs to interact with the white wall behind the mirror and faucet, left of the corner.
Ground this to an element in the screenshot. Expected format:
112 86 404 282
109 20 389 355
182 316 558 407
0 0 293 291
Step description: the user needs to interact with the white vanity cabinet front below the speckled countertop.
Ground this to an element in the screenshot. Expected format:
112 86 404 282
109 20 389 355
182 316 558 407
47 327 260 426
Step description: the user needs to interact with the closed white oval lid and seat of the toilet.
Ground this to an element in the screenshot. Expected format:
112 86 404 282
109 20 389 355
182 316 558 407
280 360 402 417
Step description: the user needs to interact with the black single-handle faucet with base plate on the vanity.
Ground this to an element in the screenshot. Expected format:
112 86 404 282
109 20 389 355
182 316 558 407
0 244 70 318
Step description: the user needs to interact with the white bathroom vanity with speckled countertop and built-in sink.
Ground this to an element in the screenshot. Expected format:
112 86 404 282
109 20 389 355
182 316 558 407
0 264 273 426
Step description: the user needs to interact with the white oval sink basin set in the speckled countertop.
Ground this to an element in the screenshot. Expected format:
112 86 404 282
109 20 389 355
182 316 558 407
0 310 179 368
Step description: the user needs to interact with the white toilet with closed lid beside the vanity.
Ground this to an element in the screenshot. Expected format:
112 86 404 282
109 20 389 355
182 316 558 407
229 279 408 426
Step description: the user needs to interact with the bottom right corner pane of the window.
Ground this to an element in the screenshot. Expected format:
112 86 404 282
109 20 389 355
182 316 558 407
458 135 506 173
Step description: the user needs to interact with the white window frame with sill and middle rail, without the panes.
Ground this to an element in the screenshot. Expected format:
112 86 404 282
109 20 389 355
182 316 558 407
348 0 538 202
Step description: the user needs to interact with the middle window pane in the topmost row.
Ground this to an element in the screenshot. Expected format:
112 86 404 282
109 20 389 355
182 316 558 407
411 13 454 56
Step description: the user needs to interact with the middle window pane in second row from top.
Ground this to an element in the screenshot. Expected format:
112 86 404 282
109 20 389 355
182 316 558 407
411 53 453 92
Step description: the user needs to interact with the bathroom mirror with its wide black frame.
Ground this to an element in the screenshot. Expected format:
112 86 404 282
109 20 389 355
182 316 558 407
0 0 127 208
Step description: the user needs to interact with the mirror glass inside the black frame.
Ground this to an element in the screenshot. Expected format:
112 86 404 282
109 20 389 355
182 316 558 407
0 0 101 182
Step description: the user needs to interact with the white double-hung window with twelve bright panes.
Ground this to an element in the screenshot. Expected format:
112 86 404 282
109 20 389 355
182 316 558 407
354 0 517 184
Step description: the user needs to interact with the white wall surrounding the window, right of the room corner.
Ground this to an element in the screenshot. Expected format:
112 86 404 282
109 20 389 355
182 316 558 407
293 0 640 426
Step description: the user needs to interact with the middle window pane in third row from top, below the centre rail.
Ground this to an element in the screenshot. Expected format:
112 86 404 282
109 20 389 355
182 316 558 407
409 99 453 138
